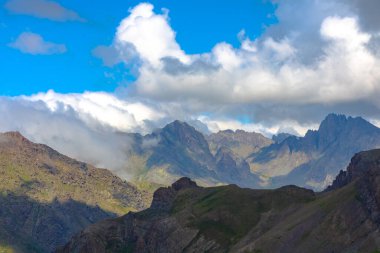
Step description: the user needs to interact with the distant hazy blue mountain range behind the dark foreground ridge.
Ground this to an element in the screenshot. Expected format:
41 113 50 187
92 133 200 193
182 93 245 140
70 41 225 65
126 114 380 190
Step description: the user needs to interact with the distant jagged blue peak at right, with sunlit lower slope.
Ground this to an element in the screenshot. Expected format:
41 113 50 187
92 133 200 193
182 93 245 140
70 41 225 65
247 114 380 190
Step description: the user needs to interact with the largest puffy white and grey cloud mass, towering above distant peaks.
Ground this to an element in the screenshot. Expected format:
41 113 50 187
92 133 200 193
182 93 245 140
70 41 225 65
93 0 380 125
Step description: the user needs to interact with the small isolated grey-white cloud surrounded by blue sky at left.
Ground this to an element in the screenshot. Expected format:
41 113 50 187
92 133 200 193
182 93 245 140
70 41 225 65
8 32 67 55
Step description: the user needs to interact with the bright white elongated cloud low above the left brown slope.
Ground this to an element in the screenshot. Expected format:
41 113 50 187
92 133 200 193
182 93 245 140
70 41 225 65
23 91 165 132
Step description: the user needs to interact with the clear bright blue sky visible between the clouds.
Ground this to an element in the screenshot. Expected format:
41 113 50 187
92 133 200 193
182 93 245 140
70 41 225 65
0 0 276 96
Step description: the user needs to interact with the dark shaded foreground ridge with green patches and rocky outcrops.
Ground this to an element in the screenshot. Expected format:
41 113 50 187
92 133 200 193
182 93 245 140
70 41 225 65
57 150 380 253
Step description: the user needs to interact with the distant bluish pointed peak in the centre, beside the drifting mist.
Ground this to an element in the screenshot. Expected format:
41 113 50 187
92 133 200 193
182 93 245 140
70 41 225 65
127 121 259 187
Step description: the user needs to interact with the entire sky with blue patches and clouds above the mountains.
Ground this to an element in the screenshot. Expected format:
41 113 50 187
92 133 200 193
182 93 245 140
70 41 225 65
0 0 380 176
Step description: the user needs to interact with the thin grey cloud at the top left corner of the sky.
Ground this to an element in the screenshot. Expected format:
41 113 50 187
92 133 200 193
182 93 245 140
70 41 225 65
5 0 84 22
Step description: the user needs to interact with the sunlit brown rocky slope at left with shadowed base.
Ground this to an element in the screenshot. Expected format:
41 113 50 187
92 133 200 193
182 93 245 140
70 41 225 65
0 132 149 252
